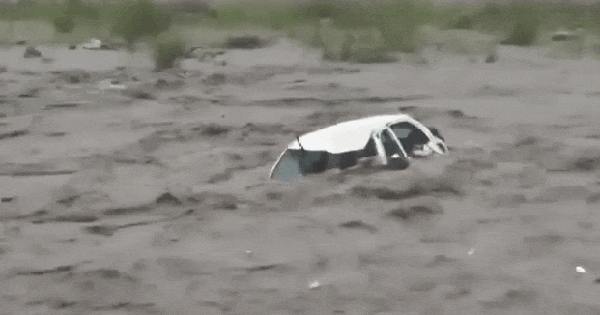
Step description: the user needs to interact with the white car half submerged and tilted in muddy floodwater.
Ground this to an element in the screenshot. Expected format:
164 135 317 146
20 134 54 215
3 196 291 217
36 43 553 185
269 114 448 181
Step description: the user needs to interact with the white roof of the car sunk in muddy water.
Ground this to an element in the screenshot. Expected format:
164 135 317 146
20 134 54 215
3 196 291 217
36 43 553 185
288 114 424 154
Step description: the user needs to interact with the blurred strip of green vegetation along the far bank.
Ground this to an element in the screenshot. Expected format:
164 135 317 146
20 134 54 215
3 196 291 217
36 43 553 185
0 0 600 63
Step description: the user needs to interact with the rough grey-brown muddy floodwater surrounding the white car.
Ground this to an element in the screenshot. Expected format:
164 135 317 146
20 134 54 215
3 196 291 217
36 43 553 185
0 43 600 315
